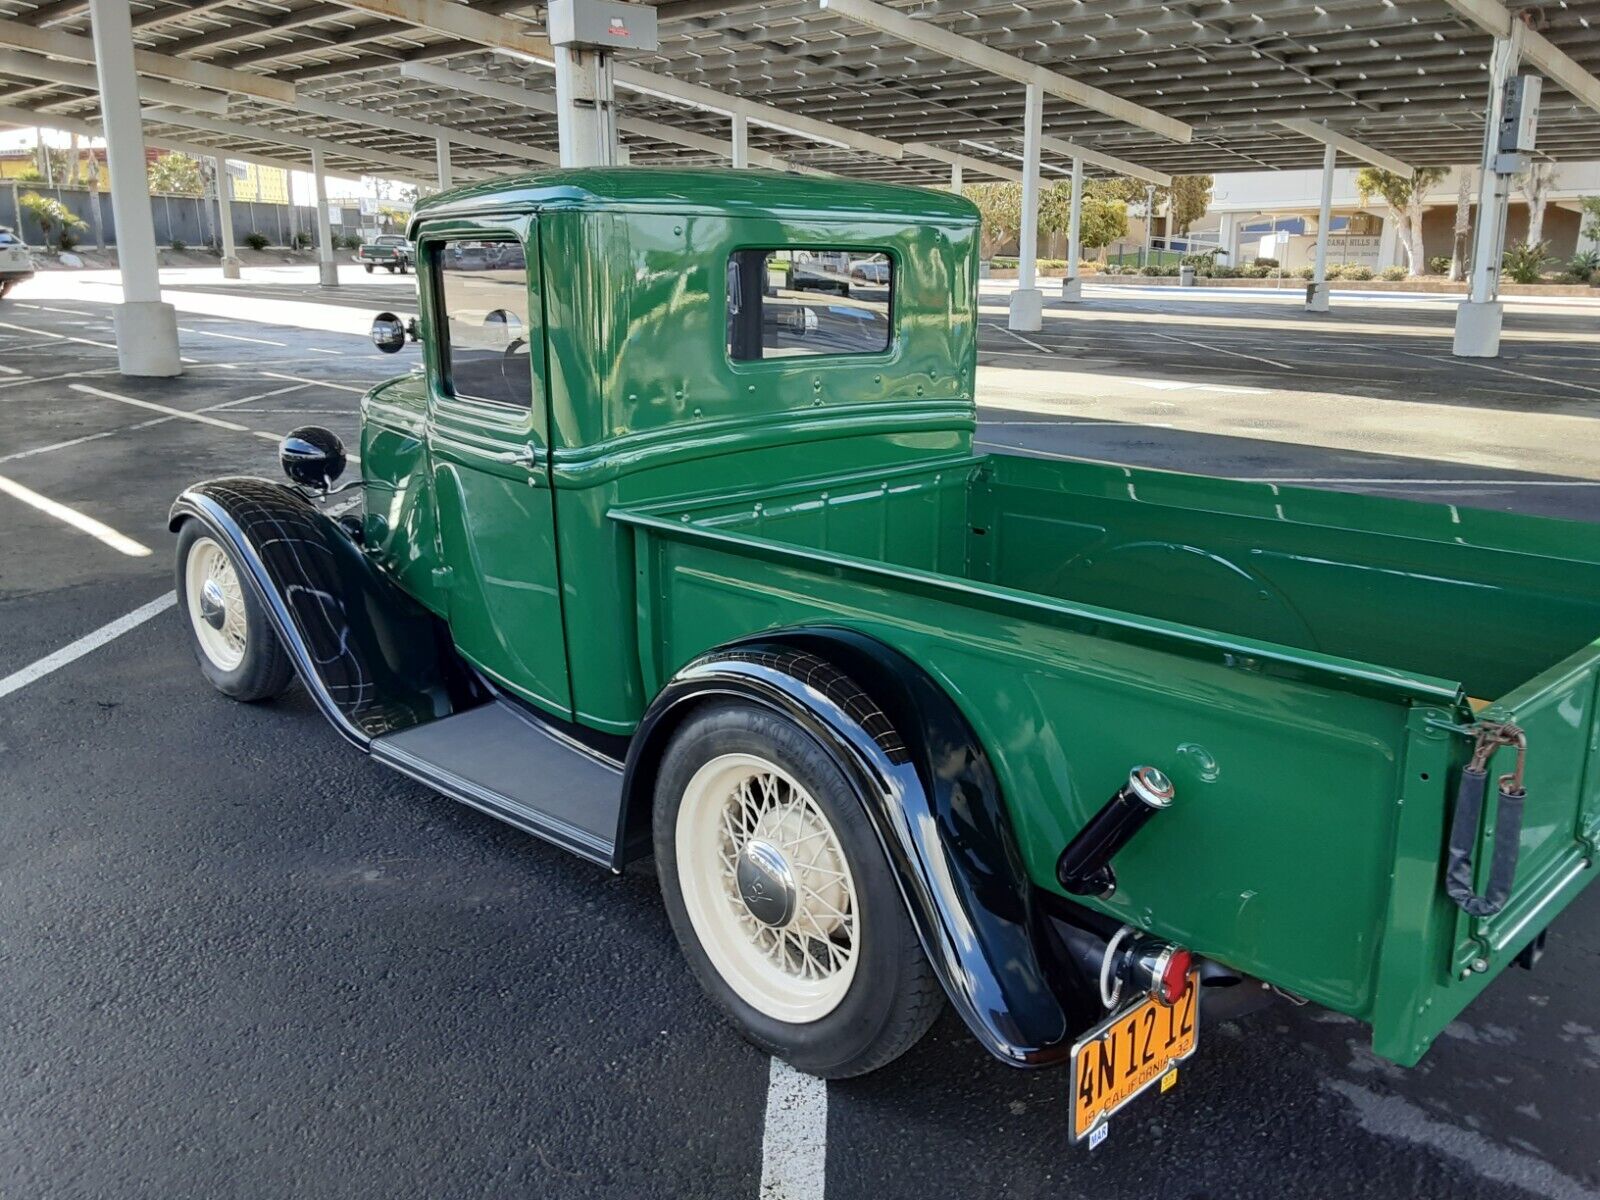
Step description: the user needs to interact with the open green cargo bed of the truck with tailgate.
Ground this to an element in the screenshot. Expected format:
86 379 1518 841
613 456 1600 1062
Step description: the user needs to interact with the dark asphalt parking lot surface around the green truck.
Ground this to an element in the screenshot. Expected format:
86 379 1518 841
0 269 1600 1200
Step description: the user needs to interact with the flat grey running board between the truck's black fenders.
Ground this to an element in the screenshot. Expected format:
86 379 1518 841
371 699 622 867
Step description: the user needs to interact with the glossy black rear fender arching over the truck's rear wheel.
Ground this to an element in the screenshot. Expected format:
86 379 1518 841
618 629 1101 1067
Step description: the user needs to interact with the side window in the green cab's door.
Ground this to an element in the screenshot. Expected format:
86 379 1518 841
432 238 538 408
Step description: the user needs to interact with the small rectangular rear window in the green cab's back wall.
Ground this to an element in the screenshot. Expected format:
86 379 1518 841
726 246 894 362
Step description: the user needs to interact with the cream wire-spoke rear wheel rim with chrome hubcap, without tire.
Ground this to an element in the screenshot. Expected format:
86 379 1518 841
677 754 861 1022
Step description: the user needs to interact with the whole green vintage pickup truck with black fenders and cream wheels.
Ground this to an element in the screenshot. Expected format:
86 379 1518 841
171 170 1600 1136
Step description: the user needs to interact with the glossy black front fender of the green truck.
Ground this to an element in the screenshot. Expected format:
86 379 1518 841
168 478 454 750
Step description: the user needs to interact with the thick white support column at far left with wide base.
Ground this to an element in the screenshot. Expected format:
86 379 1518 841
90 0 182 376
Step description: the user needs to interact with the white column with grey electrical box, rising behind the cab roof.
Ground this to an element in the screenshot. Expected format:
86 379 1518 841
549 0 658 166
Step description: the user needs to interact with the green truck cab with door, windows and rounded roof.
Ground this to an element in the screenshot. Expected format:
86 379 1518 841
362 170 978 734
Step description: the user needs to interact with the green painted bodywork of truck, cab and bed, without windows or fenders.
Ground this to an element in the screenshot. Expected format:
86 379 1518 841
362 170 1600 1062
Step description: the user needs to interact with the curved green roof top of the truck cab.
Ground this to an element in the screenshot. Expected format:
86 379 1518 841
413 166 978 224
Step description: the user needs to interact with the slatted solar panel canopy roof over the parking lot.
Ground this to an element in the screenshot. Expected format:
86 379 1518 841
0 0 1600 186
